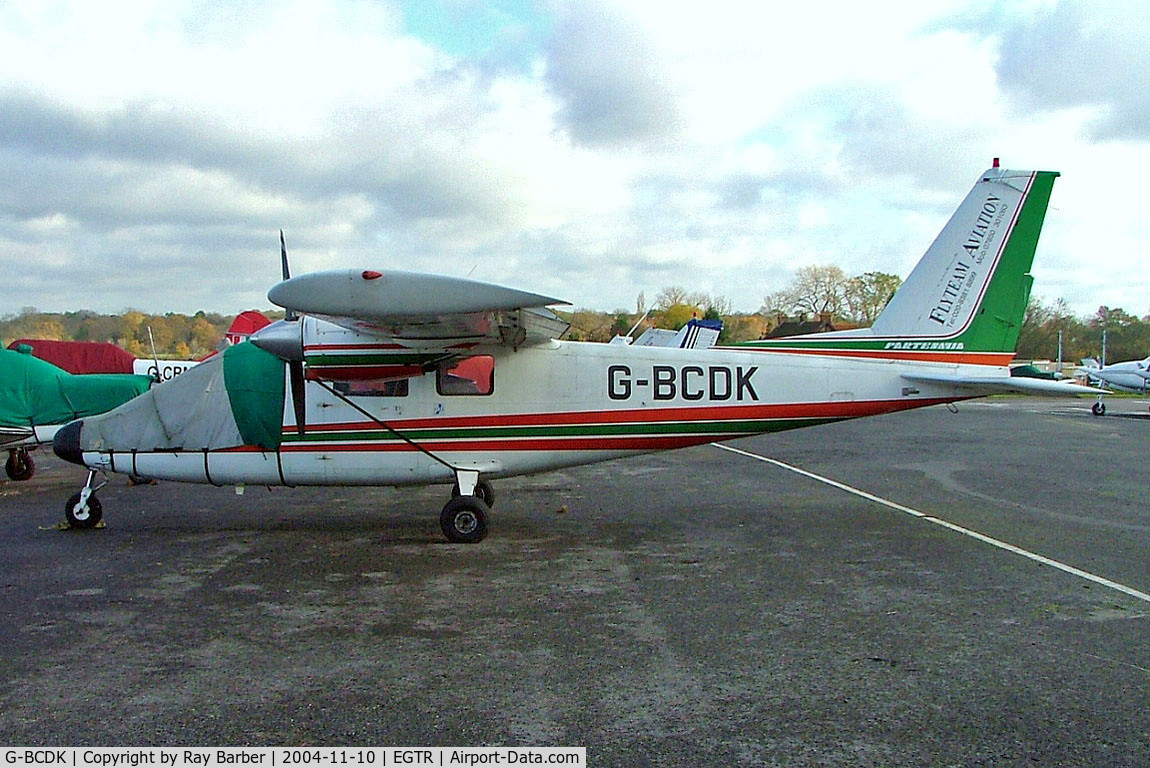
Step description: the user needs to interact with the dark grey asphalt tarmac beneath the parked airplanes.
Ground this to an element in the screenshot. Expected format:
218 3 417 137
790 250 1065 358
0 398 1150 767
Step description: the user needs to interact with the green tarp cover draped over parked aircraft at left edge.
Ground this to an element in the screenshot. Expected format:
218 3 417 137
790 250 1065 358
0 350 152 427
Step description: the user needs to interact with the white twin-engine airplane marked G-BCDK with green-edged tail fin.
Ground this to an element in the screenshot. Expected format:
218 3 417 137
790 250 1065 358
54 163 1097 543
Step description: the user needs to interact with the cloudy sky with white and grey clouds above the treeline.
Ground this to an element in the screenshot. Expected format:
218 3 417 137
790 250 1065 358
0 0 1150 315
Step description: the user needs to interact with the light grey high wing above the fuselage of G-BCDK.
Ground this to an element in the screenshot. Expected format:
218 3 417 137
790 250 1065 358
268 269 568 347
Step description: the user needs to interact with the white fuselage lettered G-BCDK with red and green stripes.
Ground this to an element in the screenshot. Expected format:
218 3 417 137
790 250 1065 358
84 341 983 485
